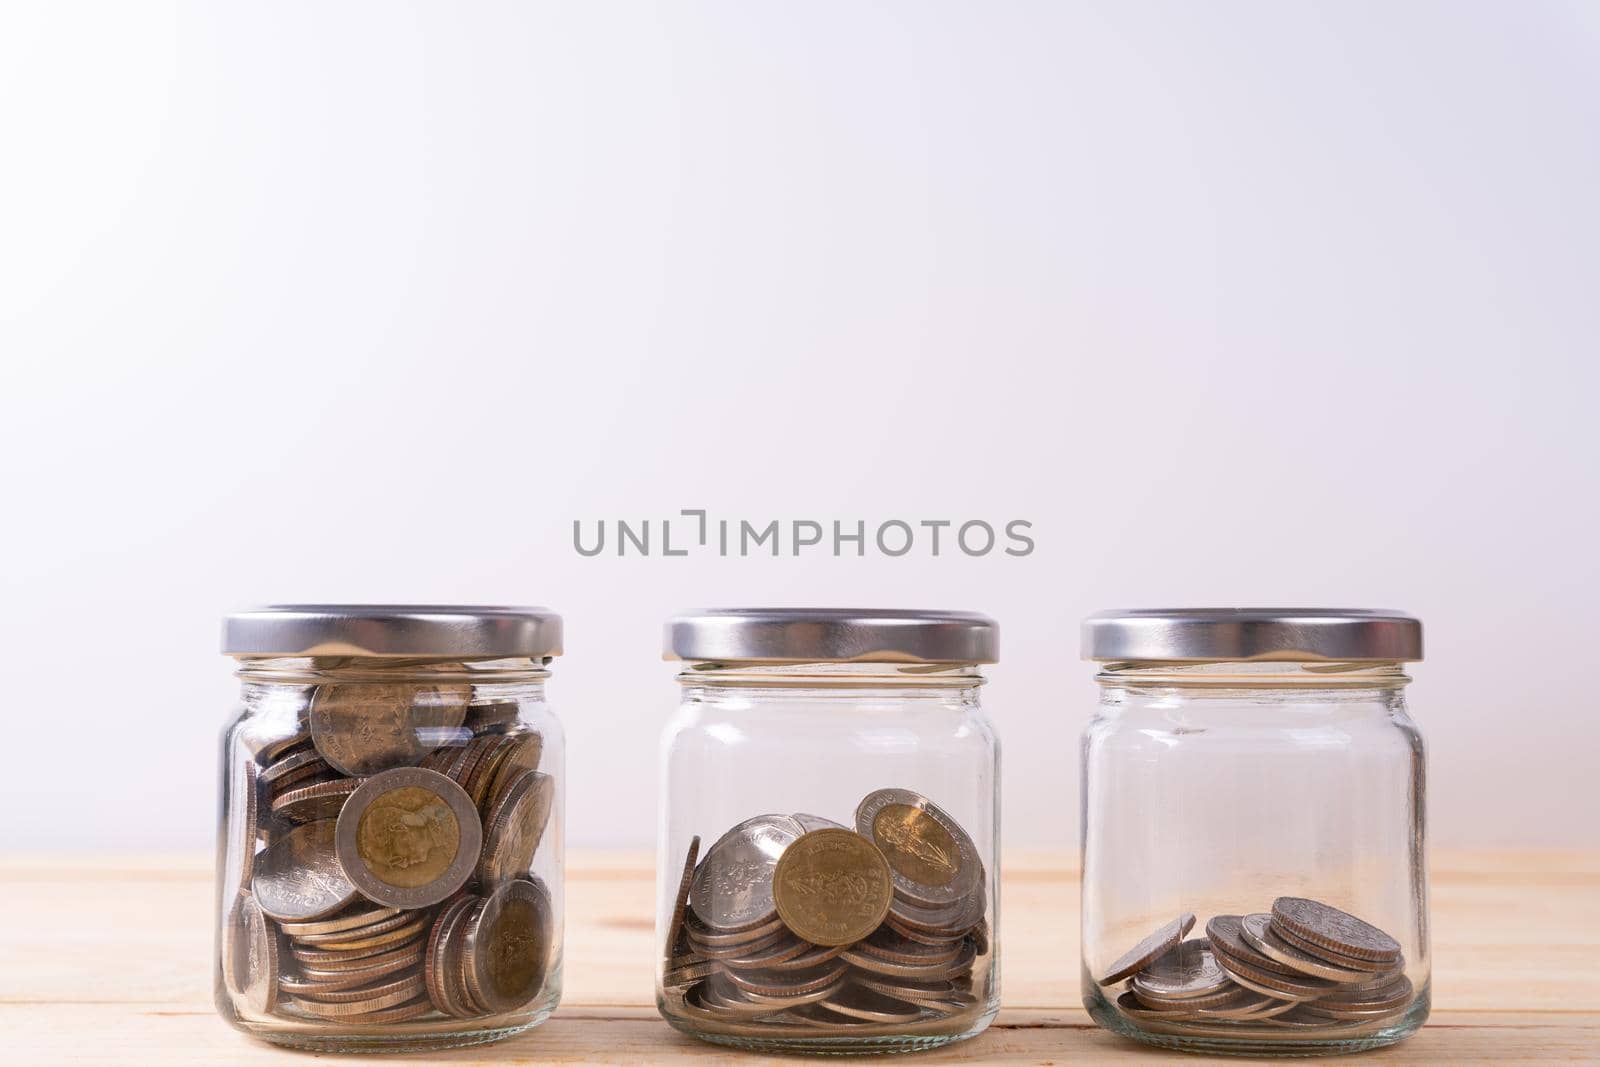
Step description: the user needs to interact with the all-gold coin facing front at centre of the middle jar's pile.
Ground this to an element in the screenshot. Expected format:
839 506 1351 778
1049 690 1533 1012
773 829 894 945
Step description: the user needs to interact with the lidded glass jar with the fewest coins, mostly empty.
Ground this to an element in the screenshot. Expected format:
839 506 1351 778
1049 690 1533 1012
1082 608 1429 1056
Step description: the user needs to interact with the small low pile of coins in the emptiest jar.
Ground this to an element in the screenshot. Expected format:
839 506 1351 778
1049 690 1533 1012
1099 896 1416 1038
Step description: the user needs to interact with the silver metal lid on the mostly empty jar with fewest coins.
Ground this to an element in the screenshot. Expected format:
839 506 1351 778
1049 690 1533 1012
1083 608 1422 662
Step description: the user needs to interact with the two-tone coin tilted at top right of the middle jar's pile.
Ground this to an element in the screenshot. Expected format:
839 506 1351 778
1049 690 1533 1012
856 789 982 907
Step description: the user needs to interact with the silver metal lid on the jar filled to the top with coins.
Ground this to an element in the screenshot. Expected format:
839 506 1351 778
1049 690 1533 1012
222 605 562 659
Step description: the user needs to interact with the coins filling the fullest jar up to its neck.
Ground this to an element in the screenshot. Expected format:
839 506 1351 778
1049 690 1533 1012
221 683 555 1027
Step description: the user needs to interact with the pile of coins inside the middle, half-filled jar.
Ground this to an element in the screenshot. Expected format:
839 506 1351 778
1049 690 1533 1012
662 789 989 1033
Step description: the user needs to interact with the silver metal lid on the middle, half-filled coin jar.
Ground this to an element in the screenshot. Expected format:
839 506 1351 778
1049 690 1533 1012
664 608 1000 664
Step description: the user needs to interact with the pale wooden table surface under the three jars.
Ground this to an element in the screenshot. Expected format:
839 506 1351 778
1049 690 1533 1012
0 851 1600 1067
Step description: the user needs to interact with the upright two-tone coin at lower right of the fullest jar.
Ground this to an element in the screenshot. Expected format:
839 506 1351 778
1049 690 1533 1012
462 880 555 1013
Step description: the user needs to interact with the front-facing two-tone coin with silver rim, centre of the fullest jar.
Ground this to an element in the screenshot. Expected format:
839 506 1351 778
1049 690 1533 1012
336 766 483 909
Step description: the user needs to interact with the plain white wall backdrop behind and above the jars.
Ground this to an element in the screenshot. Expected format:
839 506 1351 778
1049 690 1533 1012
0 0 1600 848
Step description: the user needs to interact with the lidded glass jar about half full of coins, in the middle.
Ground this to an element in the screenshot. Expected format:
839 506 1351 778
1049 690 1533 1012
656 609 1000 1053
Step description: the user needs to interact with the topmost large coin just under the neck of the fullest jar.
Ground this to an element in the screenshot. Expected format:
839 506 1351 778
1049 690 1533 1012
310 681 472 777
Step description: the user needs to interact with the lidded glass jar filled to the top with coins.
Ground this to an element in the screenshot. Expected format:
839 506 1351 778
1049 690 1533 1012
213 605 563 1051
